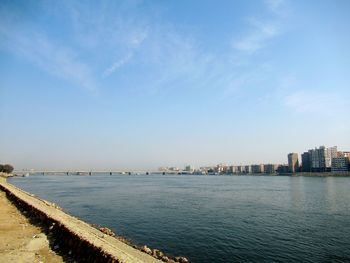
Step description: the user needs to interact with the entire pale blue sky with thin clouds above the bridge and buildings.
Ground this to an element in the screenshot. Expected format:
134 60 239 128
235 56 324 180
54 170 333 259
0 0 350 170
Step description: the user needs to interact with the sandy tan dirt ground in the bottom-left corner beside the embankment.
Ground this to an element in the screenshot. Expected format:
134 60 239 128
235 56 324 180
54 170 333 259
0 190 63 263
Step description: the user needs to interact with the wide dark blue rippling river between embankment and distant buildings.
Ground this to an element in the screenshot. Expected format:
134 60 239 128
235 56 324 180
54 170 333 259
10 175 350 262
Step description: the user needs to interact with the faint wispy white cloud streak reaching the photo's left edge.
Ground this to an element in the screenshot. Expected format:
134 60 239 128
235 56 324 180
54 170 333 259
0 19 96 91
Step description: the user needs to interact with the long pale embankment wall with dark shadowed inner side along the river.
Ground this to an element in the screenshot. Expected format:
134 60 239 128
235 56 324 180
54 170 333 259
0 177 162 263
